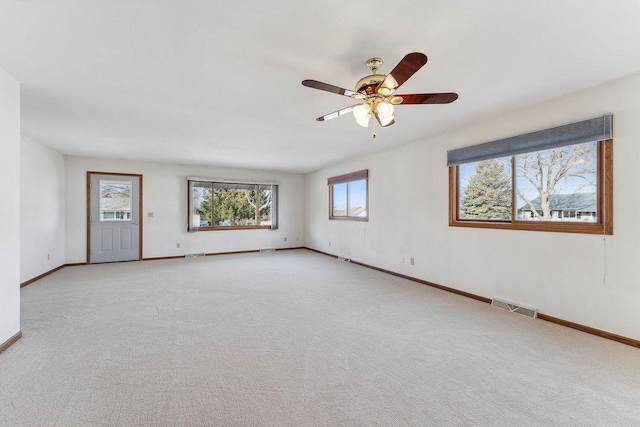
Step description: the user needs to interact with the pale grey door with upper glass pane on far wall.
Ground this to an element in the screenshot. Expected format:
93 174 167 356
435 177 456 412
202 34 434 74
89 173 141 264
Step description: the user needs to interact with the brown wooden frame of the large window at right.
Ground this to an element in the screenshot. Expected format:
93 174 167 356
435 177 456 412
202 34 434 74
449 139 613 235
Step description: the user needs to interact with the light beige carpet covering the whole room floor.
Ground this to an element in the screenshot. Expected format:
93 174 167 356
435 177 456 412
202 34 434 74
0 250 640 426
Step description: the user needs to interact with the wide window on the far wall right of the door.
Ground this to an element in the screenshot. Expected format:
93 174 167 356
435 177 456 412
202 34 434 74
188 179 278 231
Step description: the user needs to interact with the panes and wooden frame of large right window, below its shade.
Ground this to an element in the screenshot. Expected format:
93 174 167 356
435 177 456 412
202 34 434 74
450 140 613 233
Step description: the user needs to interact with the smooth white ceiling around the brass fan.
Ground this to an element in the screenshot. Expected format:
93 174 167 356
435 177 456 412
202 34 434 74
0 0 640 172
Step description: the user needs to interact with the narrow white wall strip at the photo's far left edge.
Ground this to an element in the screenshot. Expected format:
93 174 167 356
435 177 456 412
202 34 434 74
0 68 20 344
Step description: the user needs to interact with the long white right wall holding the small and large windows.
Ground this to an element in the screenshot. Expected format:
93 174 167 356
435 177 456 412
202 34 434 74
305 75 640 339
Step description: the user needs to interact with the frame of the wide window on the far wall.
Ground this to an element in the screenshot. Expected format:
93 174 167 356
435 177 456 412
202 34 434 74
187 178 279 231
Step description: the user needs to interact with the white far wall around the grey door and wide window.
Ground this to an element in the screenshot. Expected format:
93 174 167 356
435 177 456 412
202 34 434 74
65 157 304 263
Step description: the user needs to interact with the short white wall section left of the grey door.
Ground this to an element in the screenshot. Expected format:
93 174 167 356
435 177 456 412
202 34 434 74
20 136 65 282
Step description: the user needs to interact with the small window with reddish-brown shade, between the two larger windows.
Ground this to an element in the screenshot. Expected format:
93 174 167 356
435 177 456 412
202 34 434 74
327 170 369 221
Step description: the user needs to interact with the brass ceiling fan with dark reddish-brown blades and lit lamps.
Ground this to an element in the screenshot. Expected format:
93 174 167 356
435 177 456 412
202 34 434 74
302 52 458 138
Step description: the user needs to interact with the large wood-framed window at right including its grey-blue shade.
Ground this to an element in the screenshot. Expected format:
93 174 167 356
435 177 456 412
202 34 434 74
448 115 613 234
